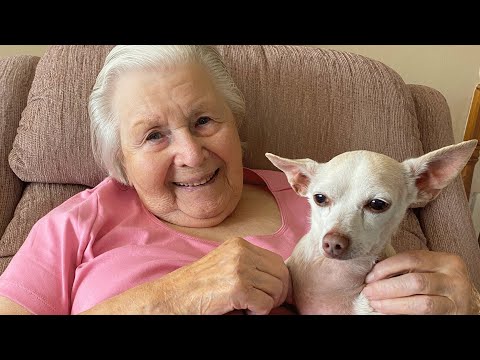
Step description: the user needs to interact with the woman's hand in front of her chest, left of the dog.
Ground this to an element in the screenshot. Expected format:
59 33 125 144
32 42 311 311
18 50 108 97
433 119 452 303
160 238 290 314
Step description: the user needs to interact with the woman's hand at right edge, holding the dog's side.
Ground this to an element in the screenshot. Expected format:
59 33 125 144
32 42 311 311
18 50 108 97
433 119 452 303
363 250 480 314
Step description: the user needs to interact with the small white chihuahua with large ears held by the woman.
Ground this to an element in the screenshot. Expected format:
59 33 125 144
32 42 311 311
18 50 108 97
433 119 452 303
265 140 477 314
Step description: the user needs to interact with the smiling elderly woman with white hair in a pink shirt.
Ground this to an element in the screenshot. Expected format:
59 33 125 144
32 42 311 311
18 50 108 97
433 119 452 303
0 45 478 314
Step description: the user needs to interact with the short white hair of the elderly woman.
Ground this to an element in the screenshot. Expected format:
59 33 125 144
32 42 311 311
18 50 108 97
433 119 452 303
88 45 245 184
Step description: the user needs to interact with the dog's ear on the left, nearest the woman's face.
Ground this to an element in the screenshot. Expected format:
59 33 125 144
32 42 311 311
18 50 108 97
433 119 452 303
265 153 316 196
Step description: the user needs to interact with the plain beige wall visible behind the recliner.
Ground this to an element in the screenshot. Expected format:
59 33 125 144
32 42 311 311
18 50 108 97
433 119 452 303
0 45 480 192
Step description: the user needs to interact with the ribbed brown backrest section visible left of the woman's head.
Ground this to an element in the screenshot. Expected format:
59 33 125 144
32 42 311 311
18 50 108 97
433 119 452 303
9 45 111 186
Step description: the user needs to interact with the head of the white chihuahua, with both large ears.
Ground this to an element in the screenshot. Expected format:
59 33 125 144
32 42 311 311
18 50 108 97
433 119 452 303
265 140 477 260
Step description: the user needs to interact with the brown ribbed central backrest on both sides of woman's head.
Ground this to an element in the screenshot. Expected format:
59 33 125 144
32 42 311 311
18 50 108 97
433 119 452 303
9 45 423 186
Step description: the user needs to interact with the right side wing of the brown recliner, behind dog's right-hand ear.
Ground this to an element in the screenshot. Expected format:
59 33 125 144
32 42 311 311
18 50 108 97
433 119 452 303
408 85 480 289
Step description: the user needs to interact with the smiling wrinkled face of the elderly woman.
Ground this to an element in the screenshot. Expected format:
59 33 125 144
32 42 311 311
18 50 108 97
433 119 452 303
113 64 243 227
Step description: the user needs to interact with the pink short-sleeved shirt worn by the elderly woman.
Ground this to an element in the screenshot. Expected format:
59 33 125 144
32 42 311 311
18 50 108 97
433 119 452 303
0 168 310 314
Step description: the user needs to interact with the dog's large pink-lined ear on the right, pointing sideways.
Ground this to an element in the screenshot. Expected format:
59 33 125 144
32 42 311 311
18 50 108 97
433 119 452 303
402 140 477 207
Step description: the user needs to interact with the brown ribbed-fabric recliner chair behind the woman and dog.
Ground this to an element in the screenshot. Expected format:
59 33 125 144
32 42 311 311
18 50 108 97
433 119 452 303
0 45 480 288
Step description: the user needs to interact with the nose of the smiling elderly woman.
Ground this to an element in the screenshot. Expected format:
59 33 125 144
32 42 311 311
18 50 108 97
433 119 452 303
173 128 208 167
